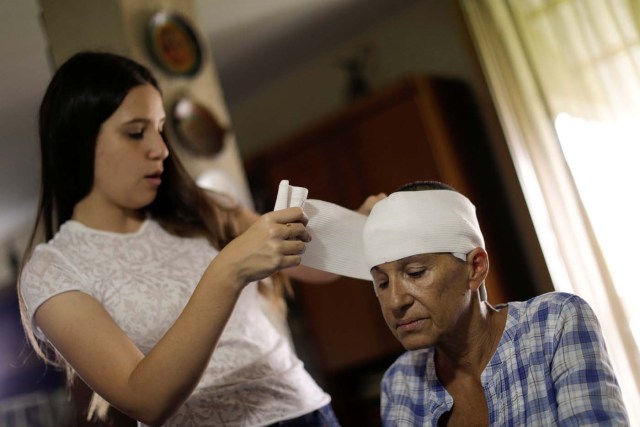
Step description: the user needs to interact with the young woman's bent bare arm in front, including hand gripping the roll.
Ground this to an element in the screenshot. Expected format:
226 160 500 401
35 208 308 425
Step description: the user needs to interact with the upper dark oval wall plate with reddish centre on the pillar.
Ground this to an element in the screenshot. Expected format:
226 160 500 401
147 11 202 76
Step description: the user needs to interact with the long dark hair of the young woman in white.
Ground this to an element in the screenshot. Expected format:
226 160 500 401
18 52 245 420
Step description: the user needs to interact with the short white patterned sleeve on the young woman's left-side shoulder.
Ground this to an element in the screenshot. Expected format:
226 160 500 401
20 245 95 341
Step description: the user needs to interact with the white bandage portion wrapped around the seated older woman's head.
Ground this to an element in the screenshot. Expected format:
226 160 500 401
363 190 484 269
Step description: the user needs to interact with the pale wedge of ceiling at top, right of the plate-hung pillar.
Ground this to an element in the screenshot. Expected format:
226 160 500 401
196 0 418 104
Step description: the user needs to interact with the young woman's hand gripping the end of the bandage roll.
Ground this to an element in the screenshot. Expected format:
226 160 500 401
214 208 311 285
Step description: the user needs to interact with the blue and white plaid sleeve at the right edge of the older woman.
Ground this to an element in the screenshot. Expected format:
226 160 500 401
551 296 629 426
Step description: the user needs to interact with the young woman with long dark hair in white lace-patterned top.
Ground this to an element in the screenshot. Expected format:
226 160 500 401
19 52 356 427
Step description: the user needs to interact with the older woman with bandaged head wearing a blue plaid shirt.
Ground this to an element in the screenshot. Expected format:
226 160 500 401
364 182 629 426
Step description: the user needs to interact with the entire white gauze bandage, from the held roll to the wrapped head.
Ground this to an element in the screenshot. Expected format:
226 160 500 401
274 181 486 301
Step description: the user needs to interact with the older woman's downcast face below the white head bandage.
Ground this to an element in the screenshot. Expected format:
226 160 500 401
371 254 471 350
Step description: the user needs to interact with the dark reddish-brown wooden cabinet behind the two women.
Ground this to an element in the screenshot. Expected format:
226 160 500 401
245 76 535 425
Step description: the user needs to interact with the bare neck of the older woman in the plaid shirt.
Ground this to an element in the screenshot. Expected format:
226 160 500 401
435 302 507 377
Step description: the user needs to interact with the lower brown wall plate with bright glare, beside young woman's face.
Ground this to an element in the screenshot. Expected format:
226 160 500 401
171 98 227 156
